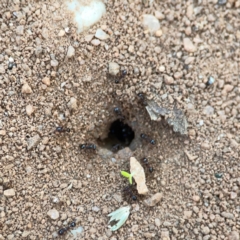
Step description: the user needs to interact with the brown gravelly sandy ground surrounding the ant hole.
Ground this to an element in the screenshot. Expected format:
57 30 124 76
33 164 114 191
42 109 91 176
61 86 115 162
0 0 240 240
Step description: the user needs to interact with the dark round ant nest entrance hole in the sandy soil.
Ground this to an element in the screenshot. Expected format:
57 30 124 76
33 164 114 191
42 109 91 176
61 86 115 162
98 119 135 153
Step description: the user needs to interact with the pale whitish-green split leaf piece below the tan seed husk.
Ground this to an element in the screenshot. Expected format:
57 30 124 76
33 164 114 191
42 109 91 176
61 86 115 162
108 206 130 231
